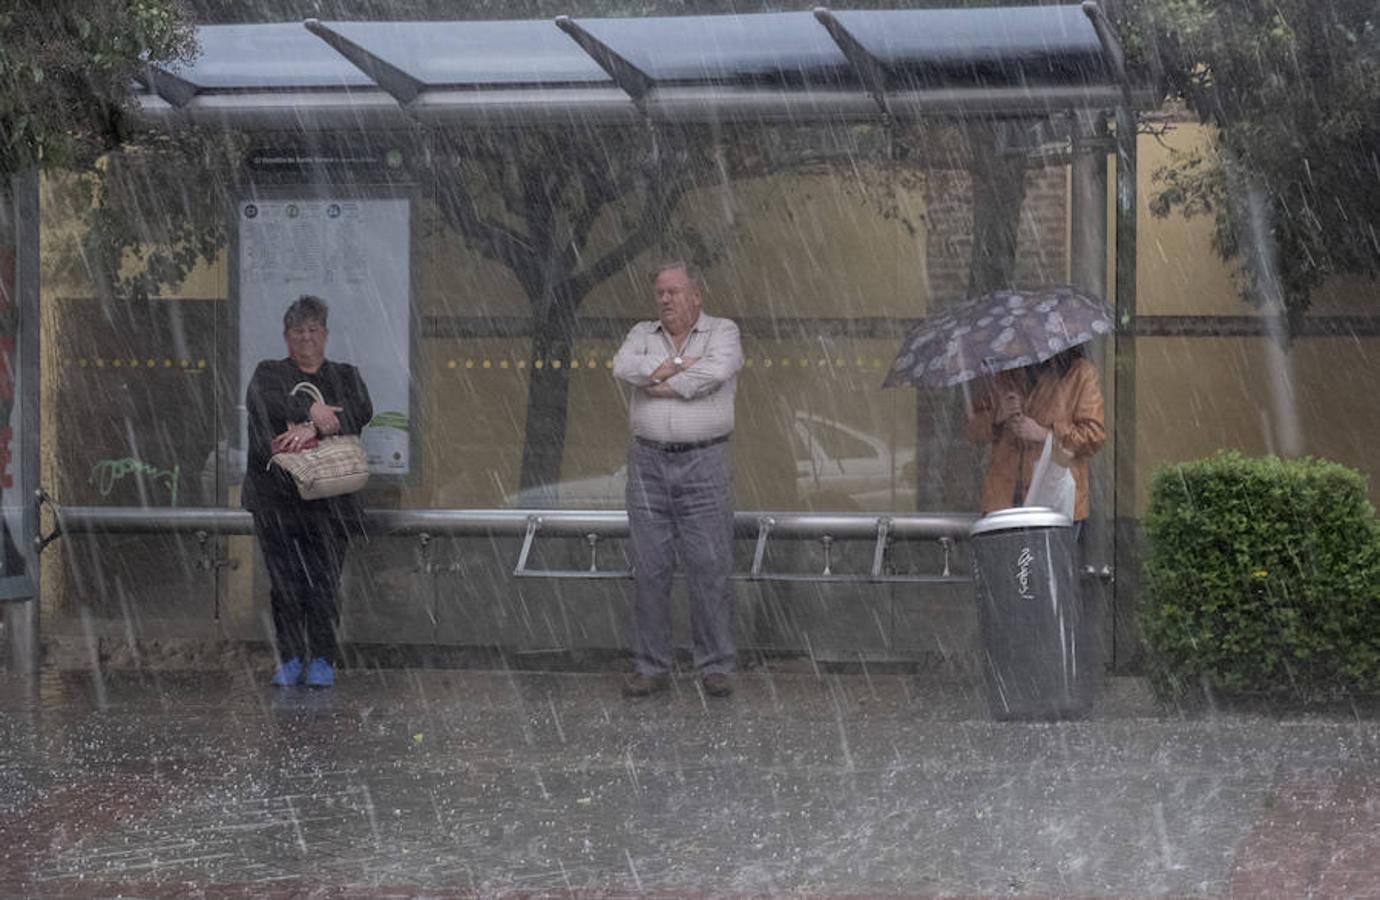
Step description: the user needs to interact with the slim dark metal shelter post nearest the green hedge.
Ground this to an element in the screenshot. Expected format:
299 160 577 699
1111 104 1143 672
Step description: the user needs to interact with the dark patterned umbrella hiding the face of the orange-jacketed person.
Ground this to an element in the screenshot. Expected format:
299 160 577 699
882 286 1114 388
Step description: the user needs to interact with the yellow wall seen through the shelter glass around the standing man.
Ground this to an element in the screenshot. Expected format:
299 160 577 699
403 164 927 509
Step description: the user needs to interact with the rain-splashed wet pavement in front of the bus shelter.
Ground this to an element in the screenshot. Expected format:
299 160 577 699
0 667 1380 897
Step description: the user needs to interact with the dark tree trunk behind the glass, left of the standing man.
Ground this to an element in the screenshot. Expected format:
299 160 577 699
519 296 575 508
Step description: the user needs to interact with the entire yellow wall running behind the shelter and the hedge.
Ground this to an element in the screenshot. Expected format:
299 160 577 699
44 123 1380 524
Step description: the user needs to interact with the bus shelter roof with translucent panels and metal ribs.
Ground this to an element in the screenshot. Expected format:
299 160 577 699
138 0 1144 131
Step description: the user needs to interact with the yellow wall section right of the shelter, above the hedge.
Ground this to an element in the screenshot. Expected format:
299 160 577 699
1136 123 1380 508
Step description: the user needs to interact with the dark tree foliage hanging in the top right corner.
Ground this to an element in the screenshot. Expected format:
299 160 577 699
1125 0 1380 320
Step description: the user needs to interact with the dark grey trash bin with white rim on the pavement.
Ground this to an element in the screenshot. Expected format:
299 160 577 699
969 507 1100 719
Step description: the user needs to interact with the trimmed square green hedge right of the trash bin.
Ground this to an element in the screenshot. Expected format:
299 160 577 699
1143 453 1380 697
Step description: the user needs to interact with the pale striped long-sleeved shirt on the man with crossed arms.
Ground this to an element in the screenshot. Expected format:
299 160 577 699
613 312 742 443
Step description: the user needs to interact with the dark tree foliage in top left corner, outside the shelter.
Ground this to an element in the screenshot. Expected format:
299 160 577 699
0 0 193 175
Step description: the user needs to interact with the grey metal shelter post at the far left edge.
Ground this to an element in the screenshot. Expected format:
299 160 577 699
0 170 40 678
